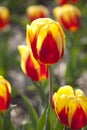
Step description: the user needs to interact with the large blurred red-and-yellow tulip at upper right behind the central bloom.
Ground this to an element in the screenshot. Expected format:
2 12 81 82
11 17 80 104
53 4 81 32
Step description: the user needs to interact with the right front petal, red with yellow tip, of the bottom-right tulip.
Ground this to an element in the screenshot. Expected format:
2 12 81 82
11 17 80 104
69 101 87 129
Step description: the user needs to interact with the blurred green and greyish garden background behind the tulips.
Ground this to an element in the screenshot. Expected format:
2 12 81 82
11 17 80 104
0 0 87 128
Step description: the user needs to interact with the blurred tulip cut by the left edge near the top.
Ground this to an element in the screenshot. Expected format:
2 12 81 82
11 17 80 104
0 6 10 30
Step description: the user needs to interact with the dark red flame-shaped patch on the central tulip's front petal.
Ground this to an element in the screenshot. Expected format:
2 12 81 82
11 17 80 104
39 32 60 64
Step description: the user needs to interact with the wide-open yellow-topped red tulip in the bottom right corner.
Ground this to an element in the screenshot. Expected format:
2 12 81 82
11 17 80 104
53 85 87 129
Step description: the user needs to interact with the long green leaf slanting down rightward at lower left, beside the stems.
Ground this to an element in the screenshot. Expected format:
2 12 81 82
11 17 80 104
18 92 38 129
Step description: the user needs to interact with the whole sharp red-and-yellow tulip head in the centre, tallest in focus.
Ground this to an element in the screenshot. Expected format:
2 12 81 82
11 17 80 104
27 18 65 65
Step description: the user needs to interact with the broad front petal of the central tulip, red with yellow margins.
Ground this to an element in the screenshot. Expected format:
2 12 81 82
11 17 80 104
37 22 65 64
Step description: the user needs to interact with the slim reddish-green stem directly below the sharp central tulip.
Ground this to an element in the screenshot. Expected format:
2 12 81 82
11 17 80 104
49 66 53 105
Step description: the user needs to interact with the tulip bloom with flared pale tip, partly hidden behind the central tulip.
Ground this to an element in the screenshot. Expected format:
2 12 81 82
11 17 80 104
18 45 48 81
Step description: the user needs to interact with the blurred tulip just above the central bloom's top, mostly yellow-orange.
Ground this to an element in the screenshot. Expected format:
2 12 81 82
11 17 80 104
26 5 49 21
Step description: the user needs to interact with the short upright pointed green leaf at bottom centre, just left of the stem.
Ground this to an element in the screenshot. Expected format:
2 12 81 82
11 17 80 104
37 107 47 130
